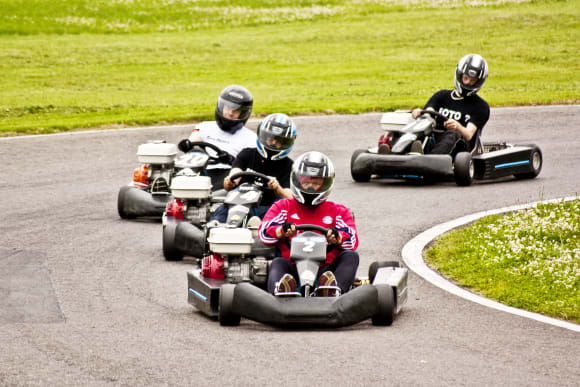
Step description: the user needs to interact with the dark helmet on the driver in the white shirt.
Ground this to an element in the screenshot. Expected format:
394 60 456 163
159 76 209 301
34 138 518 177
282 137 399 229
215 85 254 132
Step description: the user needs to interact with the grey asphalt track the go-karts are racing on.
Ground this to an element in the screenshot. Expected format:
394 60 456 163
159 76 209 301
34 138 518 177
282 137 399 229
0 106 580 386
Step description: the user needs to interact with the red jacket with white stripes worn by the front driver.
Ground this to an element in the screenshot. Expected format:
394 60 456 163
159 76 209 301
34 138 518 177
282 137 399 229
258 198 358 263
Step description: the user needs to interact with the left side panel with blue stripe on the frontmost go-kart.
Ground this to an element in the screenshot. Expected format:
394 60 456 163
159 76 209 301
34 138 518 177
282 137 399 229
187 270 223 318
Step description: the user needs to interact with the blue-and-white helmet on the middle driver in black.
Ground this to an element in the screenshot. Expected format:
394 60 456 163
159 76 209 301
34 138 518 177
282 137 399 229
256 113 296 160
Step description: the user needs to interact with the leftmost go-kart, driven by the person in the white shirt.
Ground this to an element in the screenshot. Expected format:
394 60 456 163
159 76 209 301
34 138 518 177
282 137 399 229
117 141 230 219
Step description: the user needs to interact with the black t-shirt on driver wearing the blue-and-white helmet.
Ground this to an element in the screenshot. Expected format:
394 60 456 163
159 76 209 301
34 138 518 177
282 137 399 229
232 148 294 206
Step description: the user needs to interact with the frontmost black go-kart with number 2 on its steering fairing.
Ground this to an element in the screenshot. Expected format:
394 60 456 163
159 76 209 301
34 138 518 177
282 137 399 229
188 224 408 328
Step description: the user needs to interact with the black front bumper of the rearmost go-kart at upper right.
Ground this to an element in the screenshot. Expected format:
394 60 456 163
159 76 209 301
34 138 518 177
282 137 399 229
351 152 453 177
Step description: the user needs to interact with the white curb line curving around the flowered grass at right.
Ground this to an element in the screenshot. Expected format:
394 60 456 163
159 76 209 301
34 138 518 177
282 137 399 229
402 196 580 332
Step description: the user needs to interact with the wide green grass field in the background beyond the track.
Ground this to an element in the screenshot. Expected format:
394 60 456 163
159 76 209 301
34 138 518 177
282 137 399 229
0 0 580 135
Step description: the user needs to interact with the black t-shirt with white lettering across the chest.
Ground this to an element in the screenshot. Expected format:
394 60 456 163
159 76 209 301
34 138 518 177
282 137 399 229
425 90 489 147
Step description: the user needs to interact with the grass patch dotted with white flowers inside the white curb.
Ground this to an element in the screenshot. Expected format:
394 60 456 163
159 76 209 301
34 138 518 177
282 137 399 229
425 199 580 323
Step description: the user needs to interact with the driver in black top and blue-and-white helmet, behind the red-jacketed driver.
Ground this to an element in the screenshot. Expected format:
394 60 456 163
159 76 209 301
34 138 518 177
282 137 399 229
211 113 296 223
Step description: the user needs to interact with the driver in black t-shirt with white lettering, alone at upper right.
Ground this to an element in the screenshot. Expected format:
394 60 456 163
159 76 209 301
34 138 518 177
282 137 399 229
411 54 489 157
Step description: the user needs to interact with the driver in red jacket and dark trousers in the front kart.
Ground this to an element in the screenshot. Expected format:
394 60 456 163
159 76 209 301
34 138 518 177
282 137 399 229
259 152 359 296
